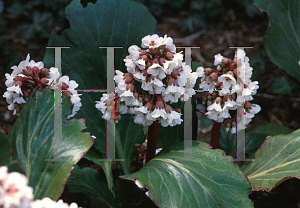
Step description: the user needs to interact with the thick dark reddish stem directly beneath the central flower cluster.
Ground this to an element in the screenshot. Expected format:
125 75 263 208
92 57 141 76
146 121 157 163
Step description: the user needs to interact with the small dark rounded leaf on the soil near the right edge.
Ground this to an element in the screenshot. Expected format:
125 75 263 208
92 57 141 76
272 77 296 95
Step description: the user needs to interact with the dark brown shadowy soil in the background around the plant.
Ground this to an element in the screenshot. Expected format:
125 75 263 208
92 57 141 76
0 0 300 207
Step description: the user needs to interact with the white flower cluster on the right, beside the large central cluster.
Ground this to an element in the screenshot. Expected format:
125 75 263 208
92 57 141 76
199 49 260 133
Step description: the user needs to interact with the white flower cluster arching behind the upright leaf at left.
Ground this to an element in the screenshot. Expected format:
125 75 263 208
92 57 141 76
3 54 81 119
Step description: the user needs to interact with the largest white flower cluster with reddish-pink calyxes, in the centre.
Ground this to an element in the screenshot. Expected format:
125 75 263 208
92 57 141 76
96 34 199 127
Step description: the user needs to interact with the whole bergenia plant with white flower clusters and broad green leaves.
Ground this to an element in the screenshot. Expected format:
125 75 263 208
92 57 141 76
0 0 300 208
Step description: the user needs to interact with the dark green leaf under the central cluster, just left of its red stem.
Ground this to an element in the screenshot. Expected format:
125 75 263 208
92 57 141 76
115 115 145 174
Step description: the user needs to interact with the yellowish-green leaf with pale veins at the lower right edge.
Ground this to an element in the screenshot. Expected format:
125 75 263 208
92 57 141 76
241 130 300 191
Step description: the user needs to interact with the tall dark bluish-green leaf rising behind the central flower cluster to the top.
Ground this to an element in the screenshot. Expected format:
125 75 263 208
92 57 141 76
44 0 156 153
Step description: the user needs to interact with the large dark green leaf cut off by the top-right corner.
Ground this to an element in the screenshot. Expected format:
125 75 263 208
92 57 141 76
255 0 300 80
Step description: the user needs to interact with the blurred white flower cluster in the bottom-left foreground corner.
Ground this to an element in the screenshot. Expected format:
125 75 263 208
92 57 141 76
0 166 78 208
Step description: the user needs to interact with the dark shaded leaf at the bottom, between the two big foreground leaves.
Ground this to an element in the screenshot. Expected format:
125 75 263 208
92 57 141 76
67 167 117 208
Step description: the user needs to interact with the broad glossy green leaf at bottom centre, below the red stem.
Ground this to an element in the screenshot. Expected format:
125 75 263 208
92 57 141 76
119 141 253 208
